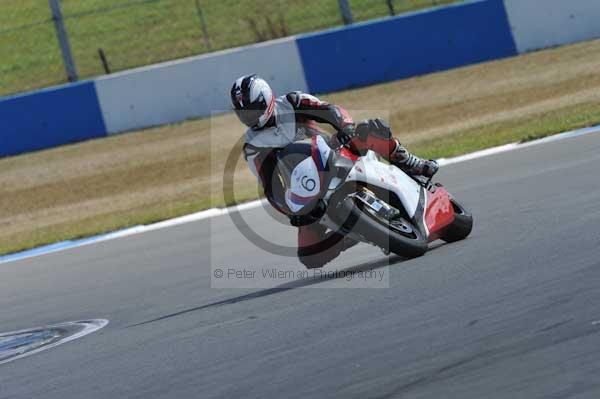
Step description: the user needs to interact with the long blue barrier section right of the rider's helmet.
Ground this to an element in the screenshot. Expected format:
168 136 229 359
297 0 517 93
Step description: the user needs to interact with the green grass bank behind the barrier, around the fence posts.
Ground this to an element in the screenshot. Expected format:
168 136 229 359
0 0 462 96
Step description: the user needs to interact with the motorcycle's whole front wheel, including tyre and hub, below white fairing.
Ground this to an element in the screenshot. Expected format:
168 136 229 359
332 197 427 258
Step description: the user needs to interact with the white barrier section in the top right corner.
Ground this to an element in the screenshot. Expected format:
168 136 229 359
504 0 600 53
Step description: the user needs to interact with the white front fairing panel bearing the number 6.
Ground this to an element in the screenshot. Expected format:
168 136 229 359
285 157 321 212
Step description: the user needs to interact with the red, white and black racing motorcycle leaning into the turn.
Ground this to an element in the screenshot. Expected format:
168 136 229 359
273 135 473 257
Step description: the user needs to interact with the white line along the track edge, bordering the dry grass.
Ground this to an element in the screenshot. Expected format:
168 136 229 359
0 126 600 264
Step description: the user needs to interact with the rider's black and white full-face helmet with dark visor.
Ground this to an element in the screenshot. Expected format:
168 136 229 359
231 75 275 129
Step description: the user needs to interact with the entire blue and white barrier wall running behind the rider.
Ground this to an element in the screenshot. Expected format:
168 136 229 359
0 0 600 156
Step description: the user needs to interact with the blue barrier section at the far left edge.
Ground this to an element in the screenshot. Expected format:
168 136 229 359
0 82 106 156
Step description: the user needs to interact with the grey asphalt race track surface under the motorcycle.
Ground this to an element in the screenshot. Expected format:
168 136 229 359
0 134 600 399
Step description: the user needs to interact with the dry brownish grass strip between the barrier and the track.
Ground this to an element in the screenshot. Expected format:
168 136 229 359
0 41 600 253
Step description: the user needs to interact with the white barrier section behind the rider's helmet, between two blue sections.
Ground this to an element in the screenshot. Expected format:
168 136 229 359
96 37 308 134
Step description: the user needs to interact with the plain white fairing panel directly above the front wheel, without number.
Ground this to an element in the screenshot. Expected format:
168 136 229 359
346 151 421 217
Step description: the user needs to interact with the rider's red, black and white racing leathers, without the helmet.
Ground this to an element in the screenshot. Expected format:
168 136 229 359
243 92 437 268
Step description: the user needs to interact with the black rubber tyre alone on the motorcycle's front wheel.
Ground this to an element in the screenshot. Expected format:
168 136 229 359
332 198 427 258
